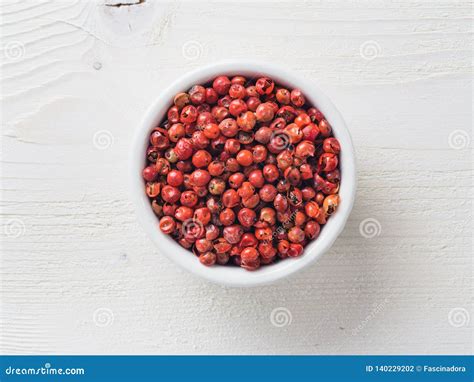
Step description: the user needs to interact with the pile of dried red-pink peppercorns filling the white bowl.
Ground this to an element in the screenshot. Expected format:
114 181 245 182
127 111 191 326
143 76 341 270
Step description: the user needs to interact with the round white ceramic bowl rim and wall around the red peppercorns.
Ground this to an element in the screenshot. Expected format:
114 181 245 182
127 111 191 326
130 61 356 287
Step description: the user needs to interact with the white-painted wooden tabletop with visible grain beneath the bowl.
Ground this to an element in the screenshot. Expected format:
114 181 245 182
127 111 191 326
0 0 474 354
